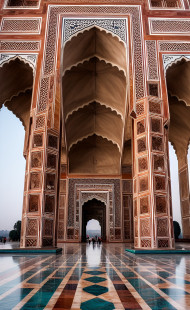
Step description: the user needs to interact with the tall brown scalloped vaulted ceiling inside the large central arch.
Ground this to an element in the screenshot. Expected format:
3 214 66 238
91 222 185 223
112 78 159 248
62 27 127 174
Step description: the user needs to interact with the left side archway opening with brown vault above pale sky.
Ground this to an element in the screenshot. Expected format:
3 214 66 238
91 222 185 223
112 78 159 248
0 57 33 236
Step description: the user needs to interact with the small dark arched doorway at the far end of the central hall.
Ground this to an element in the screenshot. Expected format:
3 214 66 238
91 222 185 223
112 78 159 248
82 199 107 242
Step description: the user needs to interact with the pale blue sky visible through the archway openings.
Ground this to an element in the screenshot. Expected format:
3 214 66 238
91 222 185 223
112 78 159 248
0 107 190 230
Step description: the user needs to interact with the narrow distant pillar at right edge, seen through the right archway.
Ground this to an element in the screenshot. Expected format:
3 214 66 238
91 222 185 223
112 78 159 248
177 149 190 239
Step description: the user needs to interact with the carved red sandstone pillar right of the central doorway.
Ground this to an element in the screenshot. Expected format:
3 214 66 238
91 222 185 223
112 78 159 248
133 97 174 249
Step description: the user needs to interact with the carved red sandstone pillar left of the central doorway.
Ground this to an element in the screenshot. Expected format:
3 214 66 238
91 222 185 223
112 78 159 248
20 72 61 248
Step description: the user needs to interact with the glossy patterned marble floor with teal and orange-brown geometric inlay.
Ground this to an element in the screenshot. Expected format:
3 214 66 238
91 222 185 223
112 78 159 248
0 244 190 310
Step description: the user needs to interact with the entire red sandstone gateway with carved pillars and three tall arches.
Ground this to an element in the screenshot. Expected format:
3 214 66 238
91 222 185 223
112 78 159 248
0 0 190 249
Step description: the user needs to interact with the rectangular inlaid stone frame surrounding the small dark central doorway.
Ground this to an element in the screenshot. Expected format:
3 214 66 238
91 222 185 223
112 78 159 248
66 178 123 242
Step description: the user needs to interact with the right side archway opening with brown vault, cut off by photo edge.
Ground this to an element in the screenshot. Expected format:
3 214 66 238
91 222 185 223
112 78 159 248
166 58 190 239
